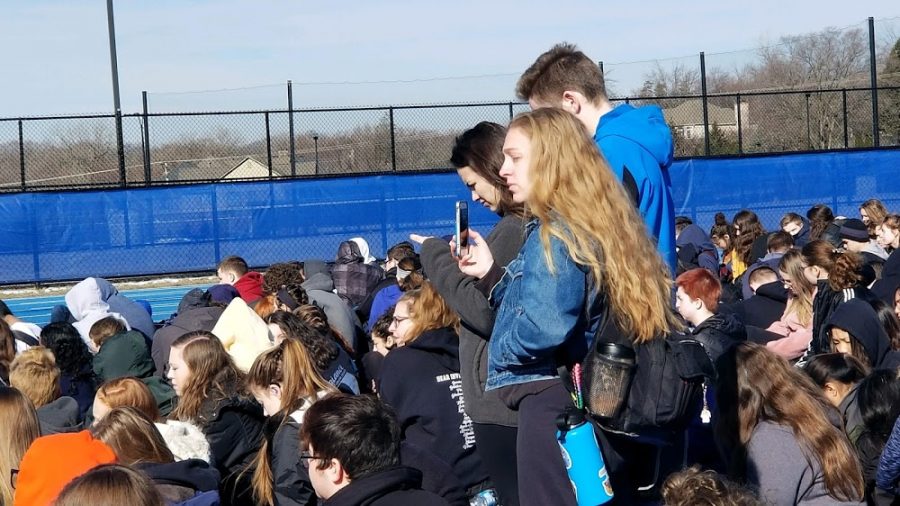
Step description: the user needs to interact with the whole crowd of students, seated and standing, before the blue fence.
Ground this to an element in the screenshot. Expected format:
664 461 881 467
0 44 900 506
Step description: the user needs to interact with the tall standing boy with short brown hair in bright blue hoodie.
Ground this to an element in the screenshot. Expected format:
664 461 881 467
516 43 676 275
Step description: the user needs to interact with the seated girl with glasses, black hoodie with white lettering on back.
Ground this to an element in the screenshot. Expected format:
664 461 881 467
378 281 487 500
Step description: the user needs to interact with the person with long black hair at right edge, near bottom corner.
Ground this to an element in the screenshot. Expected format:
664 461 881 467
856 370 900 505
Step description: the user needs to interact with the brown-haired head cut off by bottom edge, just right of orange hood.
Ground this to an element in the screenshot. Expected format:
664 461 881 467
53 464 165 506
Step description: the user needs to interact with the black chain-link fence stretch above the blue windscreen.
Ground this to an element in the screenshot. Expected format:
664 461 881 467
0 87 900 192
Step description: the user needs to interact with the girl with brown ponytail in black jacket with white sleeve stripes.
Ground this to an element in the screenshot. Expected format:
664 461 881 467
801 240 874 363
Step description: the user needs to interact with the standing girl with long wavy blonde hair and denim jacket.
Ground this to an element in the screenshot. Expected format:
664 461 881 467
459 109 679 504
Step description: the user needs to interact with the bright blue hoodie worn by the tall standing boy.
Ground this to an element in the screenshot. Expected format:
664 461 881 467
594 104 676 274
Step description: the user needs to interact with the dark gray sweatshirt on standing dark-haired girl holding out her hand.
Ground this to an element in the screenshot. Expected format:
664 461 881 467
420 216 525 427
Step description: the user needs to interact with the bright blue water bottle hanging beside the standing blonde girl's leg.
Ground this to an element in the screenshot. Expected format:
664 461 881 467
556 410 613 506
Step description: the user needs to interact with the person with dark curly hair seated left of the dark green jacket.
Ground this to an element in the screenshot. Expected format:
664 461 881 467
41 322 100 419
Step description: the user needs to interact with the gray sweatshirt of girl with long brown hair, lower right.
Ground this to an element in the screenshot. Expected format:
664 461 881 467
747 421 865 506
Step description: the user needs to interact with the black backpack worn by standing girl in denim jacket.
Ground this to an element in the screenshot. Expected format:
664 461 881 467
582 305 715 444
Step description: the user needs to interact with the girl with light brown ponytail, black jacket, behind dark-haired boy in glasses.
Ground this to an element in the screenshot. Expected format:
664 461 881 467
247 339 337 506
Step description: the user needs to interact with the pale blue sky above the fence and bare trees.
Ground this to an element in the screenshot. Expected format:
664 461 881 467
0 0 900 117
